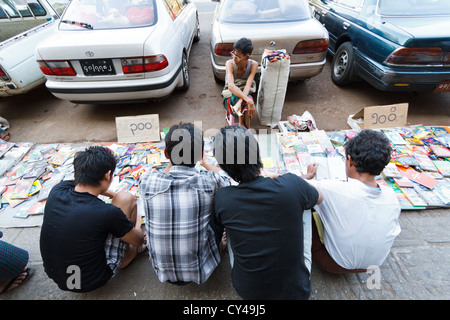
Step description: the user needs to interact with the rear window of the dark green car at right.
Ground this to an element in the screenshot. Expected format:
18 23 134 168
378 0 450 16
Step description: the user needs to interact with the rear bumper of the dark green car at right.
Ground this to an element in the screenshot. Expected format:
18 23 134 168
355 54 450 91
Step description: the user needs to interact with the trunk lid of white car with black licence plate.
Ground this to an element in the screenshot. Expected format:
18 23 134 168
37 27 155 60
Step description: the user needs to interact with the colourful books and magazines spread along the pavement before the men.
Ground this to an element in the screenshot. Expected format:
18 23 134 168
0 125 450 218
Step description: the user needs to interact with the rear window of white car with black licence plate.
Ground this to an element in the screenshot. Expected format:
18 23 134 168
59 0 156 30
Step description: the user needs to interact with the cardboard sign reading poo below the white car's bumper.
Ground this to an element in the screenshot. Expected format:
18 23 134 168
116 114 160 143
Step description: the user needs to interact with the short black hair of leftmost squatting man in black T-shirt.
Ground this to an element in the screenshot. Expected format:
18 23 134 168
73 146 116 187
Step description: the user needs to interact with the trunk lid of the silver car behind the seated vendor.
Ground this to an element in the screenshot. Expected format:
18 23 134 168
219 19 328 56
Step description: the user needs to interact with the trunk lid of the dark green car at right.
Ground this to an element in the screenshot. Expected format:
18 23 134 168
383 17 450 51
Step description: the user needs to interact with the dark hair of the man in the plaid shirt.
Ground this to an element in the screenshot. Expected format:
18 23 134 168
165 123 204 167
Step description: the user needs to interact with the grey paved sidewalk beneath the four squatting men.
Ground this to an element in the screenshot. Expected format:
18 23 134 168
0 209 450 300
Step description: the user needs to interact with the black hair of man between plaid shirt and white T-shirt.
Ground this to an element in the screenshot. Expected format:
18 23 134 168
214 126 262 183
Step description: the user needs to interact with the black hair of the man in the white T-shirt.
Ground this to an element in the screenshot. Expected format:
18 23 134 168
345 129 392 176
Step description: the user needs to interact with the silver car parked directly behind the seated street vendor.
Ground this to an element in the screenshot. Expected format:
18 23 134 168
210 0 328 83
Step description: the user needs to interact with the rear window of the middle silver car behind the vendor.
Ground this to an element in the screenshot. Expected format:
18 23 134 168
219 0 311 23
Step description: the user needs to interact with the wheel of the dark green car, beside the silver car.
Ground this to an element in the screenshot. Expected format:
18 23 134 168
331 42 354 86
